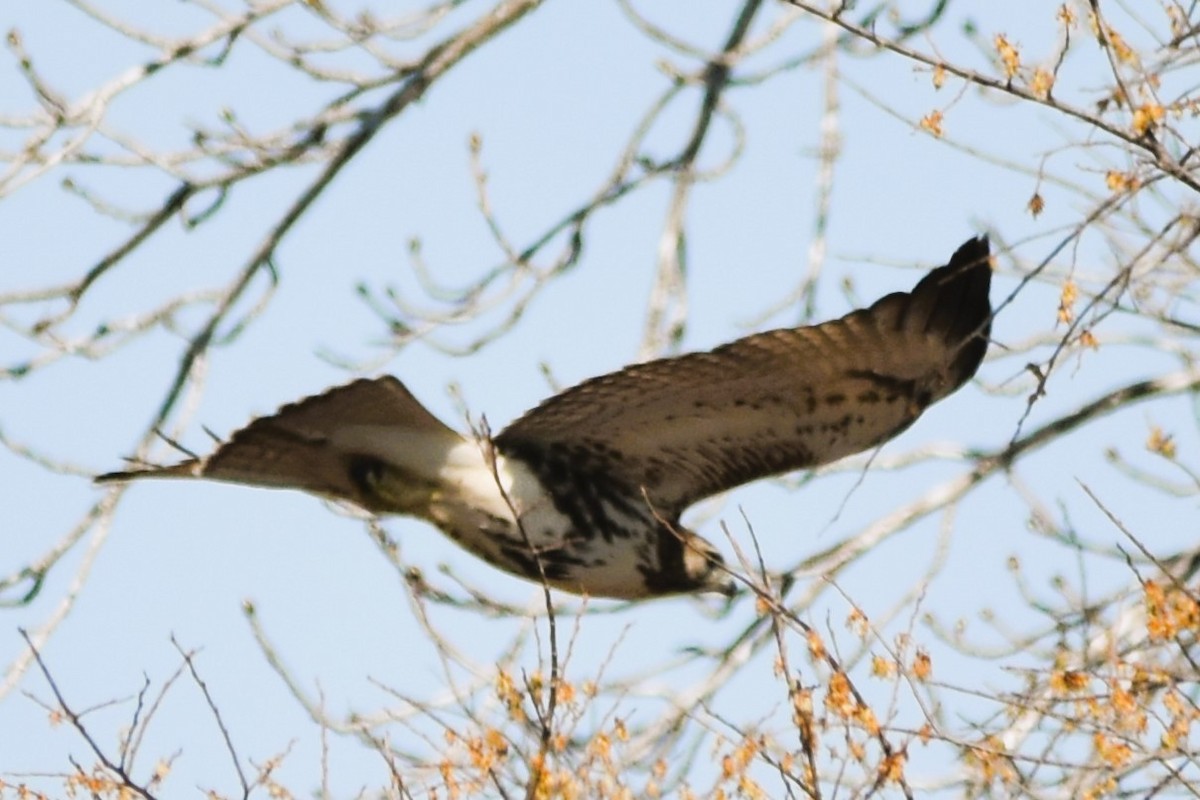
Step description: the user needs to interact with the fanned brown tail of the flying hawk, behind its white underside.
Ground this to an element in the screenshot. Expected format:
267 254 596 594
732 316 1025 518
96 375 460 507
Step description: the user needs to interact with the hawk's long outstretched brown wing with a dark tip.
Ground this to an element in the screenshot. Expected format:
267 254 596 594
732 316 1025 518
496 237 991 515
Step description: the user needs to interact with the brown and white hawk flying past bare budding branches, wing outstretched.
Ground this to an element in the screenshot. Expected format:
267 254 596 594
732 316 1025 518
96 236 991 599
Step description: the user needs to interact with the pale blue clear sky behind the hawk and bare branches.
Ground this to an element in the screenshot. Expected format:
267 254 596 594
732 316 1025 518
0 0 1196 796
